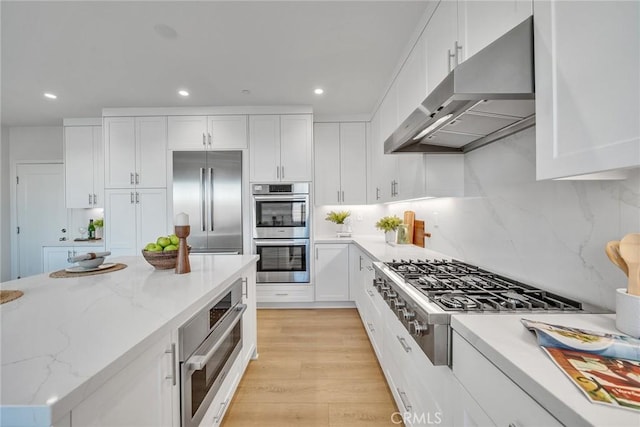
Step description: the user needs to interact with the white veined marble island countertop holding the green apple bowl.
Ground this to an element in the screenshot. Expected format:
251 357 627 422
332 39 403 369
0 255 258 421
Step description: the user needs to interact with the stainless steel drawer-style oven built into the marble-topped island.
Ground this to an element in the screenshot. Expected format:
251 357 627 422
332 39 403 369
178 279 247 427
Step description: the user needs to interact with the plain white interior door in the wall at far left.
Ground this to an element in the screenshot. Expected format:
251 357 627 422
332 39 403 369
16 163 67 278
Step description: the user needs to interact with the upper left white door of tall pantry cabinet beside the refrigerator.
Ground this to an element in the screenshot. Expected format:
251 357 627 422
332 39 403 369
104 117 136 188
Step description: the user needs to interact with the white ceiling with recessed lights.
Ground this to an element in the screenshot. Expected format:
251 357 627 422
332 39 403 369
0 0 427 126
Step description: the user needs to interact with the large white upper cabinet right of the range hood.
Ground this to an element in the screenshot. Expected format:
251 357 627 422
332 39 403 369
533 0 640 179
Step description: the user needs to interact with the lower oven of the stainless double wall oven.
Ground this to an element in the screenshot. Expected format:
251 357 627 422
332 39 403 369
253 239 309 283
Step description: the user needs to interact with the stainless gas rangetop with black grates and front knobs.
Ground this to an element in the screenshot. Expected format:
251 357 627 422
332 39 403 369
374 260 604 365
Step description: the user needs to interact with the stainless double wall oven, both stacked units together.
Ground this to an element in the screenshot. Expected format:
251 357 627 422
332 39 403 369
252 182 310 283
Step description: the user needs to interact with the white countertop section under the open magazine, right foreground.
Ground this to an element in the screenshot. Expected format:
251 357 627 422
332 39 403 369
451 314 640 427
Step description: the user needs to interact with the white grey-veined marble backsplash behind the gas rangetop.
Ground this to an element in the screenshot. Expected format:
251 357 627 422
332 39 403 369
384 128 640 310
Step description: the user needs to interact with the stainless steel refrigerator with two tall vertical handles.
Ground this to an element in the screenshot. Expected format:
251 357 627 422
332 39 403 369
173 151 242 253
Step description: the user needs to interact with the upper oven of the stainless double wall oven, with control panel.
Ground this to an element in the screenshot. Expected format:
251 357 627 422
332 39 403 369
252 182 309 239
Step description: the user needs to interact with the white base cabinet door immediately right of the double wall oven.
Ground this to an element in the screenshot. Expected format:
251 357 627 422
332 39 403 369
315 244 349 301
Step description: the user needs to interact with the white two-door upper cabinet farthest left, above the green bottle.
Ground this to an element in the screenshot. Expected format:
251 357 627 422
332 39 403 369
64 126 104 209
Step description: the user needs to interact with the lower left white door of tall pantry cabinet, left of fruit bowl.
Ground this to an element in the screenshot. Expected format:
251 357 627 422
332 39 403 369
104 189 137 256
